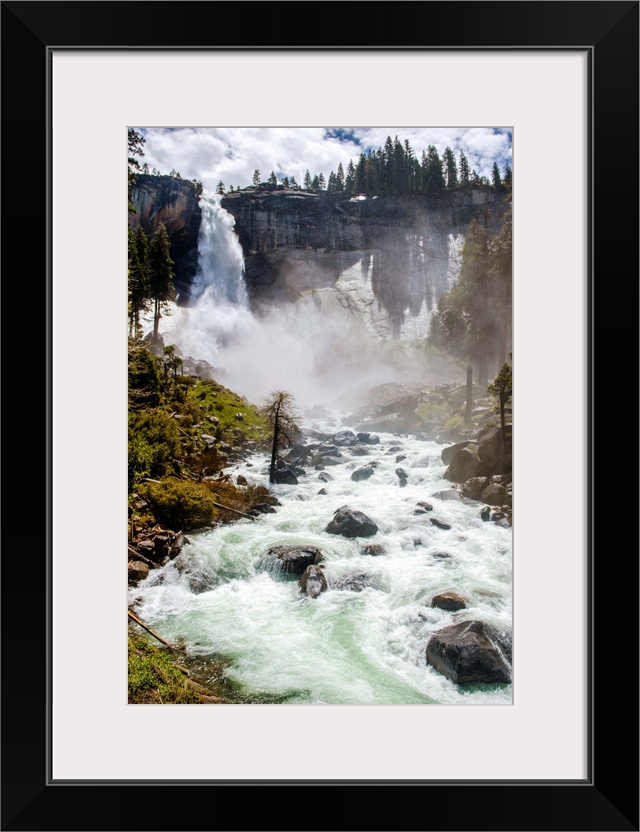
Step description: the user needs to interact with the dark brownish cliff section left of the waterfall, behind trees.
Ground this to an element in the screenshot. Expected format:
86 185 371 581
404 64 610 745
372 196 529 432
129 174 202 304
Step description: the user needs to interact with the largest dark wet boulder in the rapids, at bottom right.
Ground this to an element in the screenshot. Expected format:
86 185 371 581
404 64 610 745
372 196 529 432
426 621 511 685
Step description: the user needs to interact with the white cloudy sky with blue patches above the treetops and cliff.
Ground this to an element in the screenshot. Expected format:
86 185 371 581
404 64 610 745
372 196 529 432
136 127 512 192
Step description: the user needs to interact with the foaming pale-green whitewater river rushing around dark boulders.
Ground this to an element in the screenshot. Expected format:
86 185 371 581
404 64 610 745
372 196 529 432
129 414 512 705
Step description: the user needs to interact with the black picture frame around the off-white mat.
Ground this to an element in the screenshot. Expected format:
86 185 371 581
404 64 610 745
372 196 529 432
2 0 639 832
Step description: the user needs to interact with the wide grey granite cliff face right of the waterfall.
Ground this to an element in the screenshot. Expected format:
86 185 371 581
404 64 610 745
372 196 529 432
222 186 506 338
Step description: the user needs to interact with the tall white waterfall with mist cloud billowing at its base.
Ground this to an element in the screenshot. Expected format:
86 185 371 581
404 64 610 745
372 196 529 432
150 196 461 410
